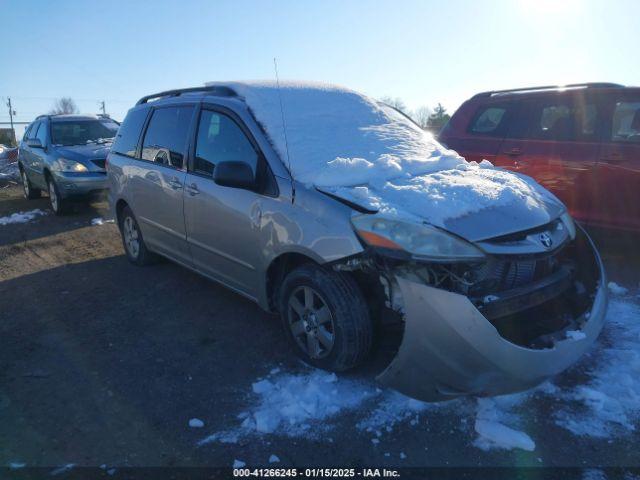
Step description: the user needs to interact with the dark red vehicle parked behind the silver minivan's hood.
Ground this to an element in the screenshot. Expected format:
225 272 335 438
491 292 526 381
438 83 640 232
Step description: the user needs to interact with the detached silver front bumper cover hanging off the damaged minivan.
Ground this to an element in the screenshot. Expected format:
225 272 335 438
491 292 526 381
378 232 608 401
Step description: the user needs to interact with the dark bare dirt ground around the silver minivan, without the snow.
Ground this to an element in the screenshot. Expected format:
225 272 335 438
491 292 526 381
0 182 640 476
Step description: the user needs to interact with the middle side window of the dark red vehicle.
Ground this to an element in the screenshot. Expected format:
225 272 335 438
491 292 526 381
510 98 598 141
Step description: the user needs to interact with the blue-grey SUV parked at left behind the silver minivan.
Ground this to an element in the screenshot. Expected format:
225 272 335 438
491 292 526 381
18 115 119 215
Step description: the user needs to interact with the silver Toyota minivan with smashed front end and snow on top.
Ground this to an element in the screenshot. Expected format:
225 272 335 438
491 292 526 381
107 82 607 401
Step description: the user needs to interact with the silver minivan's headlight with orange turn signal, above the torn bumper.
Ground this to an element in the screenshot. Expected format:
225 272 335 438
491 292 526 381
351 215 485 263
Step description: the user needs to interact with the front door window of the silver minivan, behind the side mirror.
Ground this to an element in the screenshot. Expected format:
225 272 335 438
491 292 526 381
194 110 258 176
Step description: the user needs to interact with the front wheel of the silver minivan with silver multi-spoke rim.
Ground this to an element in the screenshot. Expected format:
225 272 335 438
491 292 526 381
278 264 373 372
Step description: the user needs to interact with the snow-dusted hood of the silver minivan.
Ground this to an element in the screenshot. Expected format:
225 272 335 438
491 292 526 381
319 166 566 242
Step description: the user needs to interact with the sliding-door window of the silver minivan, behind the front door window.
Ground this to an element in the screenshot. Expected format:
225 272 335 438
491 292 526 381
142 105 193 168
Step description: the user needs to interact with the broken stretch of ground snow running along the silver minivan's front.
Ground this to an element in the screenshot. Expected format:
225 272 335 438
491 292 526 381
199 289 640 455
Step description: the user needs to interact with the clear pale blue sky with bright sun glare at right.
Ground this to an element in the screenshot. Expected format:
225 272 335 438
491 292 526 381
0 0 640 136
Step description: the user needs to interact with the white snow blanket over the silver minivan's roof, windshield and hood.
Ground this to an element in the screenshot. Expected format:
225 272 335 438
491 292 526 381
208 82 559 232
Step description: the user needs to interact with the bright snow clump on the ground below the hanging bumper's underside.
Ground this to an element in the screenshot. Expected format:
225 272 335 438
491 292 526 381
474 395 536 452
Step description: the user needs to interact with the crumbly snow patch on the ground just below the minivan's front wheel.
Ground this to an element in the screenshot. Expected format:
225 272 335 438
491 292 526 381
199 370 375 445
